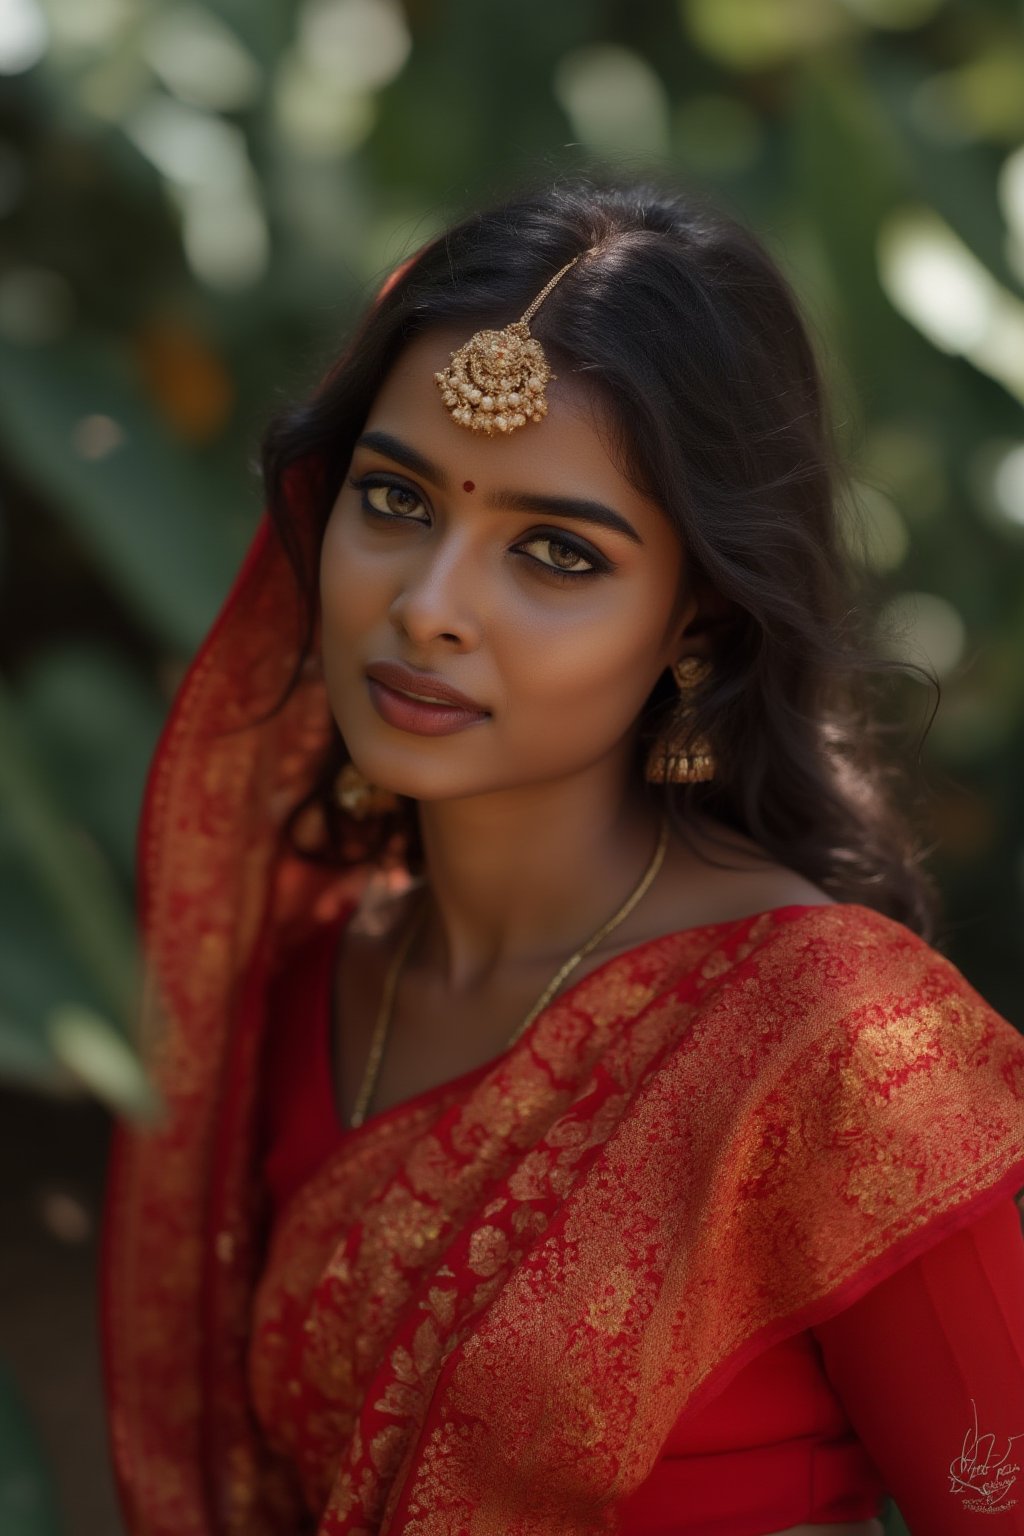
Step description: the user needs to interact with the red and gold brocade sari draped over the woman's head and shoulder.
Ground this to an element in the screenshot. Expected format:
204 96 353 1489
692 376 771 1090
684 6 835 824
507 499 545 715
101 270 1024 1536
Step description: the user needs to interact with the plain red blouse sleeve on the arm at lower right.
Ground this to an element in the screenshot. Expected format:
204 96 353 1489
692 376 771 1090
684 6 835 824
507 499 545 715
811 1200 1024 1536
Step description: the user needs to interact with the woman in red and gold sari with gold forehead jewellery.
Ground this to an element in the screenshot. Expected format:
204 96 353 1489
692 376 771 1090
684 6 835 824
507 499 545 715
103 178 1024 1536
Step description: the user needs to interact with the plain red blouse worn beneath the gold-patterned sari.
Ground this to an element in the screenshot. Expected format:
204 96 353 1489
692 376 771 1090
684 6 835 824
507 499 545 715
250 906 1024 1536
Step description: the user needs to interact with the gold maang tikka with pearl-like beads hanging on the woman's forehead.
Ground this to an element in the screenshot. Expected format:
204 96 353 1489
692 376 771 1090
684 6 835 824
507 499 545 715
434 255 579 438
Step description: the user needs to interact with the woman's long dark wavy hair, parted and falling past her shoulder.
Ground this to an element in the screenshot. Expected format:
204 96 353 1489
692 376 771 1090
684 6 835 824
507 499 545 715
261 165 938 937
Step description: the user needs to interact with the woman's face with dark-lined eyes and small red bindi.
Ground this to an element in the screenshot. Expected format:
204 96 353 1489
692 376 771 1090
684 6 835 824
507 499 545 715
319 332 697 800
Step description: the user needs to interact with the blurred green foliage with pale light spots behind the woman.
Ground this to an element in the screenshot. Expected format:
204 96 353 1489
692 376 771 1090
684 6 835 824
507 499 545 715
0 0 1024 1533
